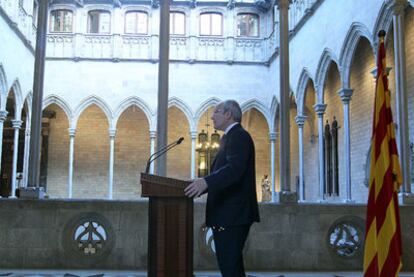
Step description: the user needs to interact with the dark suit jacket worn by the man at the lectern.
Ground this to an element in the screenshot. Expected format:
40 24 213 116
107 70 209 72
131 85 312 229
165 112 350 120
205 124 260 227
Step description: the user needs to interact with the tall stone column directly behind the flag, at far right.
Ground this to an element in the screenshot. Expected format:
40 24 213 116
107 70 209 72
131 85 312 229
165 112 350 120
388 0 411 194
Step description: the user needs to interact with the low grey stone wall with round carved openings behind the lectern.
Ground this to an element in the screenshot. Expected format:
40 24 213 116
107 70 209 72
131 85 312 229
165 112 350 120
0 199 414 272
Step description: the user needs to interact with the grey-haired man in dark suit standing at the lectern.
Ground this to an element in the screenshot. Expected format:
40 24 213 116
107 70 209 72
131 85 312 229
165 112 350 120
185 100 260 277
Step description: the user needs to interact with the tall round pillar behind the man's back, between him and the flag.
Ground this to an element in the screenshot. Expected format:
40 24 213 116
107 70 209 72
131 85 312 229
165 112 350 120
278 0 296 202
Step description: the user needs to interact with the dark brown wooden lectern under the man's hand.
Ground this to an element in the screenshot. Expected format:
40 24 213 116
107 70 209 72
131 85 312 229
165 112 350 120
141 173 193 277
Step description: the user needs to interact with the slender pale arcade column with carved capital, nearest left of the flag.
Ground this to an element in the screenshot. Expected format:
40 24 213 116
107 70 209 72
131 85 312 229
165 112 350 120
338 88 353 202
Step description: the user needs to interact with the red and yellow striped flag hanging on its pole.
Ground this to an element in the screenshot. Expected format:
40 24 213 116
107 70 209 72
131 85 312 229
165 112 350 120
364 31 402 277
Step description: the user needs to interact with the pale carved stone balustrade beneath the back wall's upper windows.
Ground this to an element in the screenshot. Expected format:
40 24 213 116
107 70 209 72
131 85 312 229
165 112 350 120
46 32 278 63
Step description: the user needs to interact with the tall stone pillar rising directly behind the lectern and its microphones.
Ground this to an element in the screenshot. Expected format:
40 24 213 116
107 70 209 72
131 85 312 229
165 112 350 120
156 0 170 176
